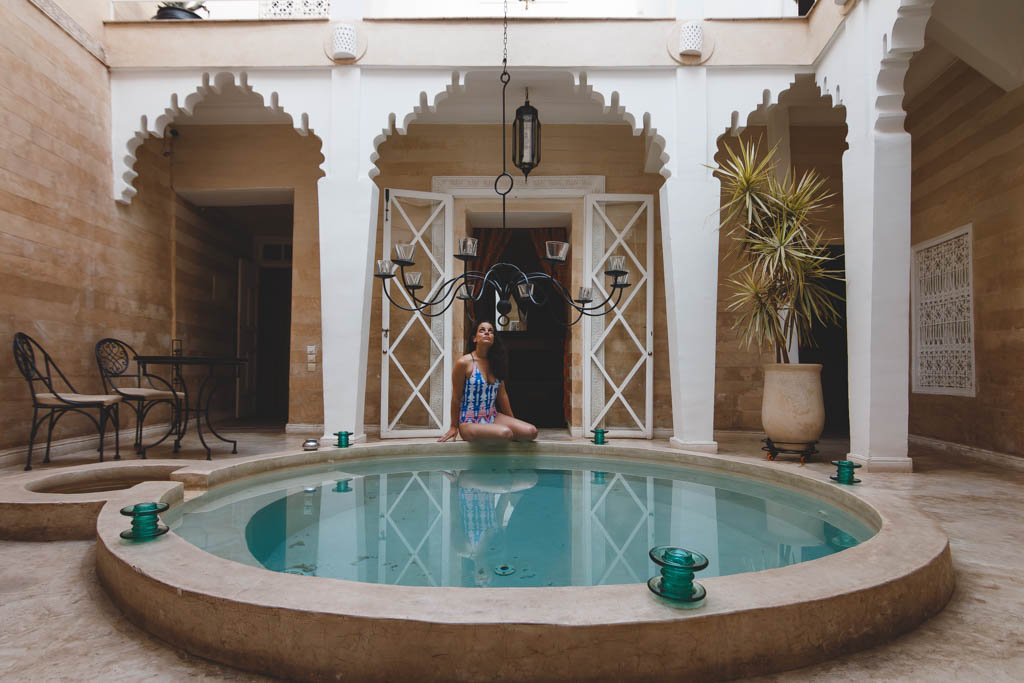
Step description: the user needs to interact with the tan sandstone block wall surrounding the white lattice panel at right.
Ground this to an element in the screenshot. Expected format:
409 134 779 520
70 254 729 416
906 61 1024 456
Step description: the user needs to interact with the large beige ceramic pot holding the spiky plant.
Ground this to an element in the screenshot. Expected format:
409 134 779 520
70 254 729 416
761 362 825 444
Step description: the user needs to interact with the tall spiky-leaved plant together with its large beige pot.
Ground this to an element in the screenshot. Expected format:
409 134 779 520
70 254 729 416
716 142 843 462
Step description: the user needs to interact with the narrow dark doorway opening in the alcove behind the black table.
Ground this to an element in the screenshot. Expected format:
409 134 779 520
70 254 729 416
254 267 292 423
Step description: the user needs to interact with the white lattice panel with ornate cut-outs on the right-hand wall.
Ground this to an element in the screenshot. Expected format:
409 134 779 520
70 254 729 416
911 224 975 396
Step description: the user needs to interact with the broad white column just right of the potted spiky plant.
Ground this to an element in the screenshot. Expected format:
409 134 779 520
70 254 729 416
843 124 912 472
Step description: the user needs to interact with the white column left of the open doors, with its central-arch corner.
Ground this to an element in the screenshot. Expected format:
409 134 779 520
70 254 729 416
317 67 459 440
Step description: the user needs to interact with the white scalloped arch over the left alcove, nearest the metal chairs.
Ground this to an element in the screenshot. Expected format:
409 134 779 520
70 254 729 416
112 71 323 204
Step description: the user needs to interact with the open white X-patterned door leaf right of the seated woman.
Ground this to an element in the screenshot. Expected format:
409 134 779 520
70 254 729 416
584 195 654 438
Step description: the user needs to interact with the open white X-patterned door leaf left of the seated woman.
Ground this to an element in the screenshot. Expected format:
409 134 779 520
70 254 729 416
381 189 453 438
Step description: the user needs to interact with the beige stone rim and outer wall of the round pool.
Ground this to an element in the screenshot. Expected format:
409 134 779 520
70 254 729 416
95 442 953 681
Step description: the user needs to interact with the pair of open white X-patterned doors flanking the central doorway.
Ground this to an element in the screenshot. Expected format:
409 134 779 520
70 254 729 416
379 189 654 438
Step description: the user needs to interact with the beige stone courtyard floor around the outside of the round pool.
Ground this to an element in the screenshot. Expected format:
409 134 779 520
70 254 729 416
0 426 1024 681
